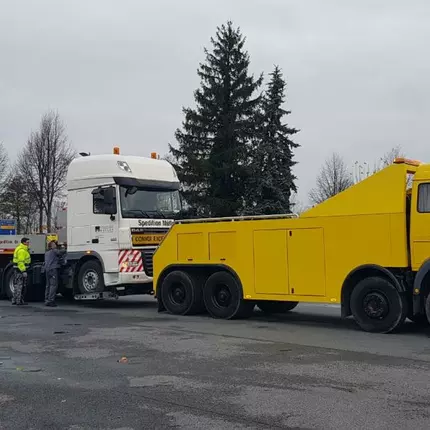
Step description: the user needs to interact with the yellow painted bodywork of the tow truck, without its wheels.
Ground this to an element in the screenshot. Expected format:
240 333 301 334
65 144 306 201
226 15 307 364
154 164 430 303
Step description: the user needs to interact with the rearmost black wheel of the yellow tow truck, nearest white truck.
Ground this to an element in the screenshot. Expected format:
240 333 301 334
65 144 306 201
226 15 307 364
160 270 204 315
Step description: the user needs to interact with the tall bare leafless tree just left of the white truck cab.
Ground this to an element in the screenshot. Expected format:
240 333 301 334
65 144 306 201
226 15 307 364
18 111 76 231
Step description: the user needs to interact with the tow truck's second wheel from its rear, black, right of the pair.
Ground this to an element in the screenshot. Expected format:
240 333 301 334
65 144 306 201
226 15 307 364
203 272 255 319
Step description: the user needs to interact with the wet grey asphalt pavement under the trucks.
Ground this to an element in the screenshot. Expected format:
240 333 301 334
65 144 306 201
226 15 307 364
0 298 430 430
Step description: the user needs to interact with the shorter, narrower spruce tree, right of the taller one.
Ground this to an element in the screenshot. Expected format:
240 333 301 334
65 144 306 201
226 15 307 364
247 66 300 214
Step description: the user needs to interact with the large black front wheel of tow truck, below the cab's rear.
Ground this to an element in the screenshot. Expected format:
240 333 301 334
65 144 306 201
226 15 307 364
351 277 408 333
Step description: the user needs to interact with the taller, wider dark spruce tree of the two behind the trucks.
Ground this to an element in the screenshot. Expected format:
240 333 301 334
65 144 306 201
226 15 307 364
170 22 262 216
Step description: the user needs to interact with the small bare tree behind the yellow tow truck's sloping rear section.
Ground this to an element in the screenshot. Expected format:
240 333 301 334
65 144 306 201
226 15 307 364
309 153 353 204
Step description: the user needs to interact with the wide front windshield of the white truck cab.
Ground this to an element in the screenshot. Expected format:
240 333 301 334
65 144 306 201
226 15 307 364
120 187 181 218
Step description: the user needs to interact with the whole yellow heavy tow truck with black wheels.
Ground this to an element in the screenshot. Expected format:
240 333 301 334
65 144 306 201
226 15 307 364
154 159 430 333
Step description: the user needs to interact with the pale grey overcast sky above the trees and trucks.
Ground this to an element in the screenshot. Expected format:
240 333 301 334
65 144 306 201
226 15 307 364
0 0 430 201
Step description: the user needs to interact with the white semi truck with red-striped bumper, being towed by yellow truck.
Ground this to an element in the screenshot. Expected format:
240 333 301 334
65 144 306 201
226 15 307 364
1 147 181 300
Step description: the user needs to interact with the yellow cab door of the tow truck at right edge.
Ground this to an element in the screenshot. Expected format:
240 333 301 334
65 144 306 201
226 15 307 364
410 182 430 270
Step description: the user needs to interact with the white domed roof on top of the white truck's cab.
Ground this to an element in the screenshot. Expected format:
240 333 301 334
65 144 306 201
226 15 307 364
67 154 178 190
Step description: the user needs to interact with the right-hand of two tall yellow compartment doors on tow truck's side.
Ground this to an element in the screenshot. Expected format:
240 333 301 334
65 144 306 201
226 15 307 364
288 228 326 296
